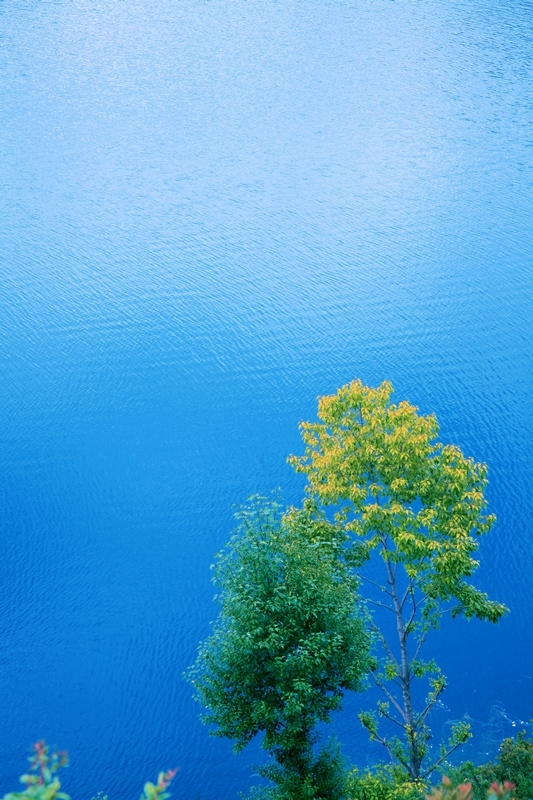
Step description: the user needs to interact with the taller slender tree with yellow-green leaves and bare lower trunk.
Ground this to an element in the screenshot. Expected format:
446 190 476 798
289 380 506 780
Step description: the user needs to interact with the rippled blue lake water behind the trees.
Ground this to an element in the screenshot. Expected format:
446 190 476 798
0 0 533 800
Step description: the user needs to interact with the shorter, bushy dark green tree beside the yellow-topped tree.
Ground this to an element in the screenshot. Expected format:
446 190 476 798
190 498 369 800
